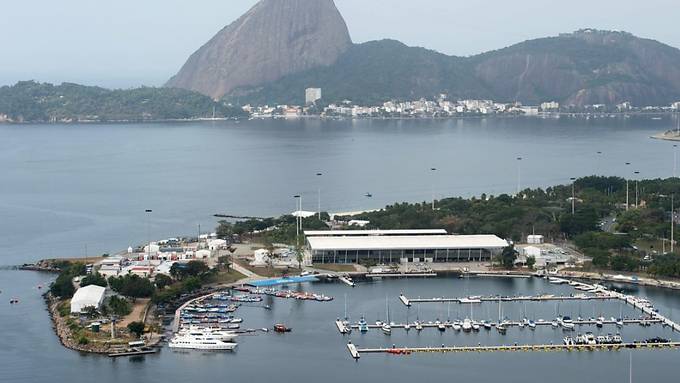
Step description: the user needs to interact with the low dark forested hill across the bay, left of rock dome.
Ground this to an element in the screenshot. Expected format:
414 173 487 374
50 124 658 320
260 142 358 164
0 81 245 122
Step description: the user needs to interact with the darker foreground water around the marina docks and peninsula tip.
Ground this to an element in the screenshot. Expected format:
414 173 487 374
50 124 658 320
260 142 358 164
0 272 680 383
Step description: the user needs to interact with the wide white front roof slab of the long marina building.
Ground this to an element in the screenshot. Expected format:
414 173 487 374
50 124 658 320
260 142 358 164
307 235 508 250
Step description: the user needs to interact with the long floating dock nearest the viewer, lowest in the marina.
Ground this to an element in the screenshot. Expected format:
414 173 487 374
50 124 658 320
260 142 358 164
347 342 680 359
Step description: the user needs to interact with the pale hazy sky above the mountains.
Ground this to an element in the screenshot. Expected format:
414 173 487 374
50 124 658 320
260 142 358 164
0 0 680 88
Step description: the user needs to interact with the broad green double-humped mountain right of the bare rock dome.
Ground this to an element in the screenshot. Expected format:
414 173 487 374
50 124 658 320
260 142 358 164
226 29 680 106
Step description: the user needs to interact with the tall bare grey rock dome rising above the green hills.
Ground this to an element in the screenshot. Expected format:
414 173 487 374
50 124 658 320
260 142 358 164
166 0 352 98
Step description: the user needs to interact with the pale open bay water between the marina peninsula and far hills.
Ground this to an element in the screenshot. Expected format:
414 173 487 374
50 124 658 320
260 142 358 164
0 118 673 265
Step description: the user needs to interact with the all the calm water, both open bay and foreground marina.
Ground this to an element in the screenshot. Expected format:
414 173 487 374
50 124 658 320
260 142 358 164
0 119 680 382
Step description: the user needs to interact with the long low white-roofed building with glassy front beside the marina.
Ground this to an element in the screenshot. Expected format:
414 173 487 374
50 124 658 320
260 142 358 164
305 230 508 263
